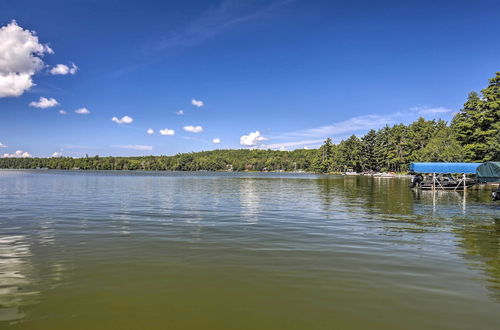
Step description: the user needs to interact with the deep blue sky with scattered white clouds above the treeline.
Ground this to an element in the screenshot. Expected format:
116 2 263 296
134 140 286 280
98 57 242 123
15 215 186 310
0 0 500 157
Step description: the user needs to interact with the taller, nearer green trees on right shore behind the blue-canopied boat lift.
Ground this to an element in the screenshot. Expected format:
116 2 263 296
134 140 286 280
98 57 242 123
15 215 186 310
313 72 500 173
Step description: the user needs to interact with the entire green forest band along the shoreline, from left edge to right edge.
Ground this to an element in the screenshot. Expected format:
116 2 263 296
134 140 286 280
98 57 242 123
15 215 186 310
0 72 500 173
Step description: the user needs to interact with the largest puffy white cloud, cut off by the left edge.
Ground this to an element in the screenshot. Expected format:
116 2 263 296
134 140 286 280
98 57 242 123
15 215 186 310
0 21 54 98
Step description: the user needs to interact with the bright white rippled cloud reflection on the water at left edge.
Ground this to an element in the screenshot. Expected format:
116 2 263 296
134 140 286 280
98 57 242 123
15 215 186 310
0 235 38 321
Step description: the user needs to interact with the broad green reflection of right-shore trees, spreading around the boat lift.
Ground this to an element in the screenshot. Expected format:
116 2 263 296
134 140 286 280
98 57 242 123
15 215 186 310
316 177 500 302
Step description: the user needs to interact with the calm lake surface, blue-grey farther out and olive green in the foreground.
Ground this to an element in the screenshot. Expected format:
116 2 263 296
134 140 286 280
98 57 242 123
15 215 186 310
0 170 500 329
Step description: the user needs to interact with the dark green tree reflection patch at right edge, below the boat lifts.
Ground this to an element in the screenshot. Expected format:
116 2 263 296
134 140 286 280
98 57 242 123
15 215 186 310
454 217 500 302
